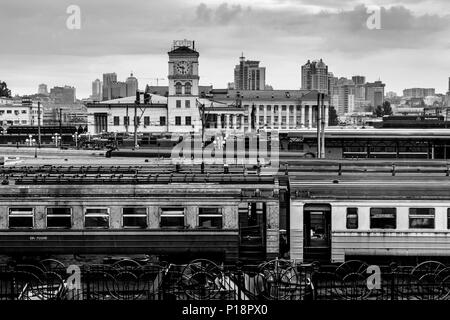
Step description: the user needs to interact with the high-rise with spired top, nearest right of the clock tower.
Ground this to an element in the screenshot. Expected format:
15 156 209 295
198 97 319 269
234 55 266 90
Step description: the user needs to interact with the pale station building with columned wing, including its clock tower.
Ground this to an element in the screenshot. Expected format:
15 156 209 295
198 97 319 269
87 40 329 133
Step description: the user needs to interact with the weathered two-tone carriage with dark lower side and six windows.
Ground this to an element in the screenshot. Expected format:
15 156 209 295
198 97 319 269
0 167 279 261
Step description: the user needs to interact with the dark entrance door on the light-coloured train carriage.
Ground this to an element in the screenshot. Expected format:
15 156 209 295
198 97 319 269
303 204 331 262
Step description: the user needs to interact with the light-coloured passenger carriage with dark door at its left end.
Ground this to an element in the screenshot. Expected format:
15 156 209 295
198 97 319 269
289 164 450 262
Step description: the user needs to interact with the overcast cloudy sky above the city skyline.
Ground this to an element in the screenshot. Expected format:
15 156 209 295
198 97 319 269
0 0 450 98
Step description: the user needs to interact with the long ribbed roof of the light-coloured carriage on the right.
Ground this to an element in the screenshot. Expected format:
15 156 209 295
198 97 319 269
288 160 450 201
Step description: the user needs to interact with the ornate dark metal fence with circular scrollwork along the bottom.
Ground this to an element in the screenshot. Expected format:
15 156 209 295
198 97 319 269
0 260 450 301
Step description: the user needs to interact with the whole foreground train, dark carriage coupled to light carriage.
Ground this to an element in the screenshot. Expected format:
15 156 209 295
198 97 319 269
0 160 450 263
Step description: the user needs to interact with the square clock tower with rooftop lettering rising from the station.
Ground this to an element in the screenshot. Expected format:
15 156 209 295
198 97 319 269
167 40 201 132
